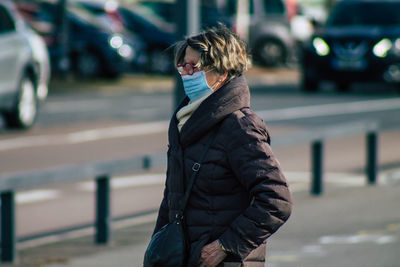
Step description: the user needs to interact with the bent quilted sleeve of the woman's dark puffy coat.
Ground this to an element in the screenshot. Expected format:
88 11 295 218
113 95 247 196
220 114 292 259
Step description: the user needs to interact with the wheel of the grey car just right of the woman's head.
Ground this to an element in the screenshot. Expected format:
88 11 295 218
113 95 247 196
256 39 286 67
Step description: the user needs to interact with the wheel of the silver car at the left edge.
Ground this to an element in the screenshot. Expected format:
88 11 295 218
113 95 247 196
4 75 38 129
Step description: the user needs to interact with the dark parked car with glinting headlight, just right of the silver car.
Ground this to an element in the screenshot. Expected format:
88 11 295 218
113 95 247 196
15 1 147 78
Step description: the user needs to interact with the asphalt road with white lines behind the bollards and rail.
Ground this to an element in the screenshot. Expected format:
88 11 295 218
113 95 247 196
0 70 400 266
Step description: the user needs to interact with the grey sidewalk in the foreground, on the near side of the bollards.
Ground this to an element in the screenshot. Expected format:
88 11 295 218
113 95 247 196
4 172 400 267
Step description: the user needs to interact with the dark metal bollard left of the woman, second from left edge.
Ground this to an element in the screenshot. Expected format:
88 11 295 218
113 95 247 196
95 176 111 244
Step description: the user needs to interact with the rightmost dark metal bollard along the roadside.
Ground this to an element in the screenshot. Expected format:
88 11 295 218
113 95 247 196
366 132 378 185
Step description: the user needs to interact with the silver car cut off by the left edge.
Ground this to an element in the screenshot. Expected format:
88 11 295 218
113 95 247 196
0 1 50 129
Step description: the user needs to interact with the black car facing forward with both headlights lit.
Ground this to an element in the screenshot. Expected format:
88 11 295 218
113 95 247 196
301 0 400 91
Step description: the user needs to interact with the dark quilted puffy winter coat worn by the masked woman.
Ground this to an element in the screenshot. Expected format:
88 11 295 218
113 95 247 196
155 76 292 266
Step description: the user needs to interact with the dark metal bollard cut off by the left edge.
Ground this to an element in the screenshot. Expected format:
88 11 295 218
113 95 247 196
1 191 16 262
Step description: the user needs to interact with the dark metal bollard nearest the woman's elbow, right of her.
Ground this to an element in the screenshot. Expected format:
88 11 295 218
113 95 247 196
311 141 323 196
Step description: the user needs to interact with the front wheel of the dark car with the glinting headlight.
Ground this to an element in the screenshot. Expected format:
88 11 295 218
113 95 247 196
76 52 101 78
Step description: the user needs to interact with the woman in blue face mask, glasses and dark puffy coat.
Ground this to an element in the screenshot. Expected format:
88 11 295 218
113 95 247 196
154 25 291 267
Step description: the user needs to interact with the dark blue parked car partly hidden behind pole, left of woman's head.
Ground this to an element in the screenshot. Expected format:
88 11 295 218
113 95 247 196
73 0 175 73
